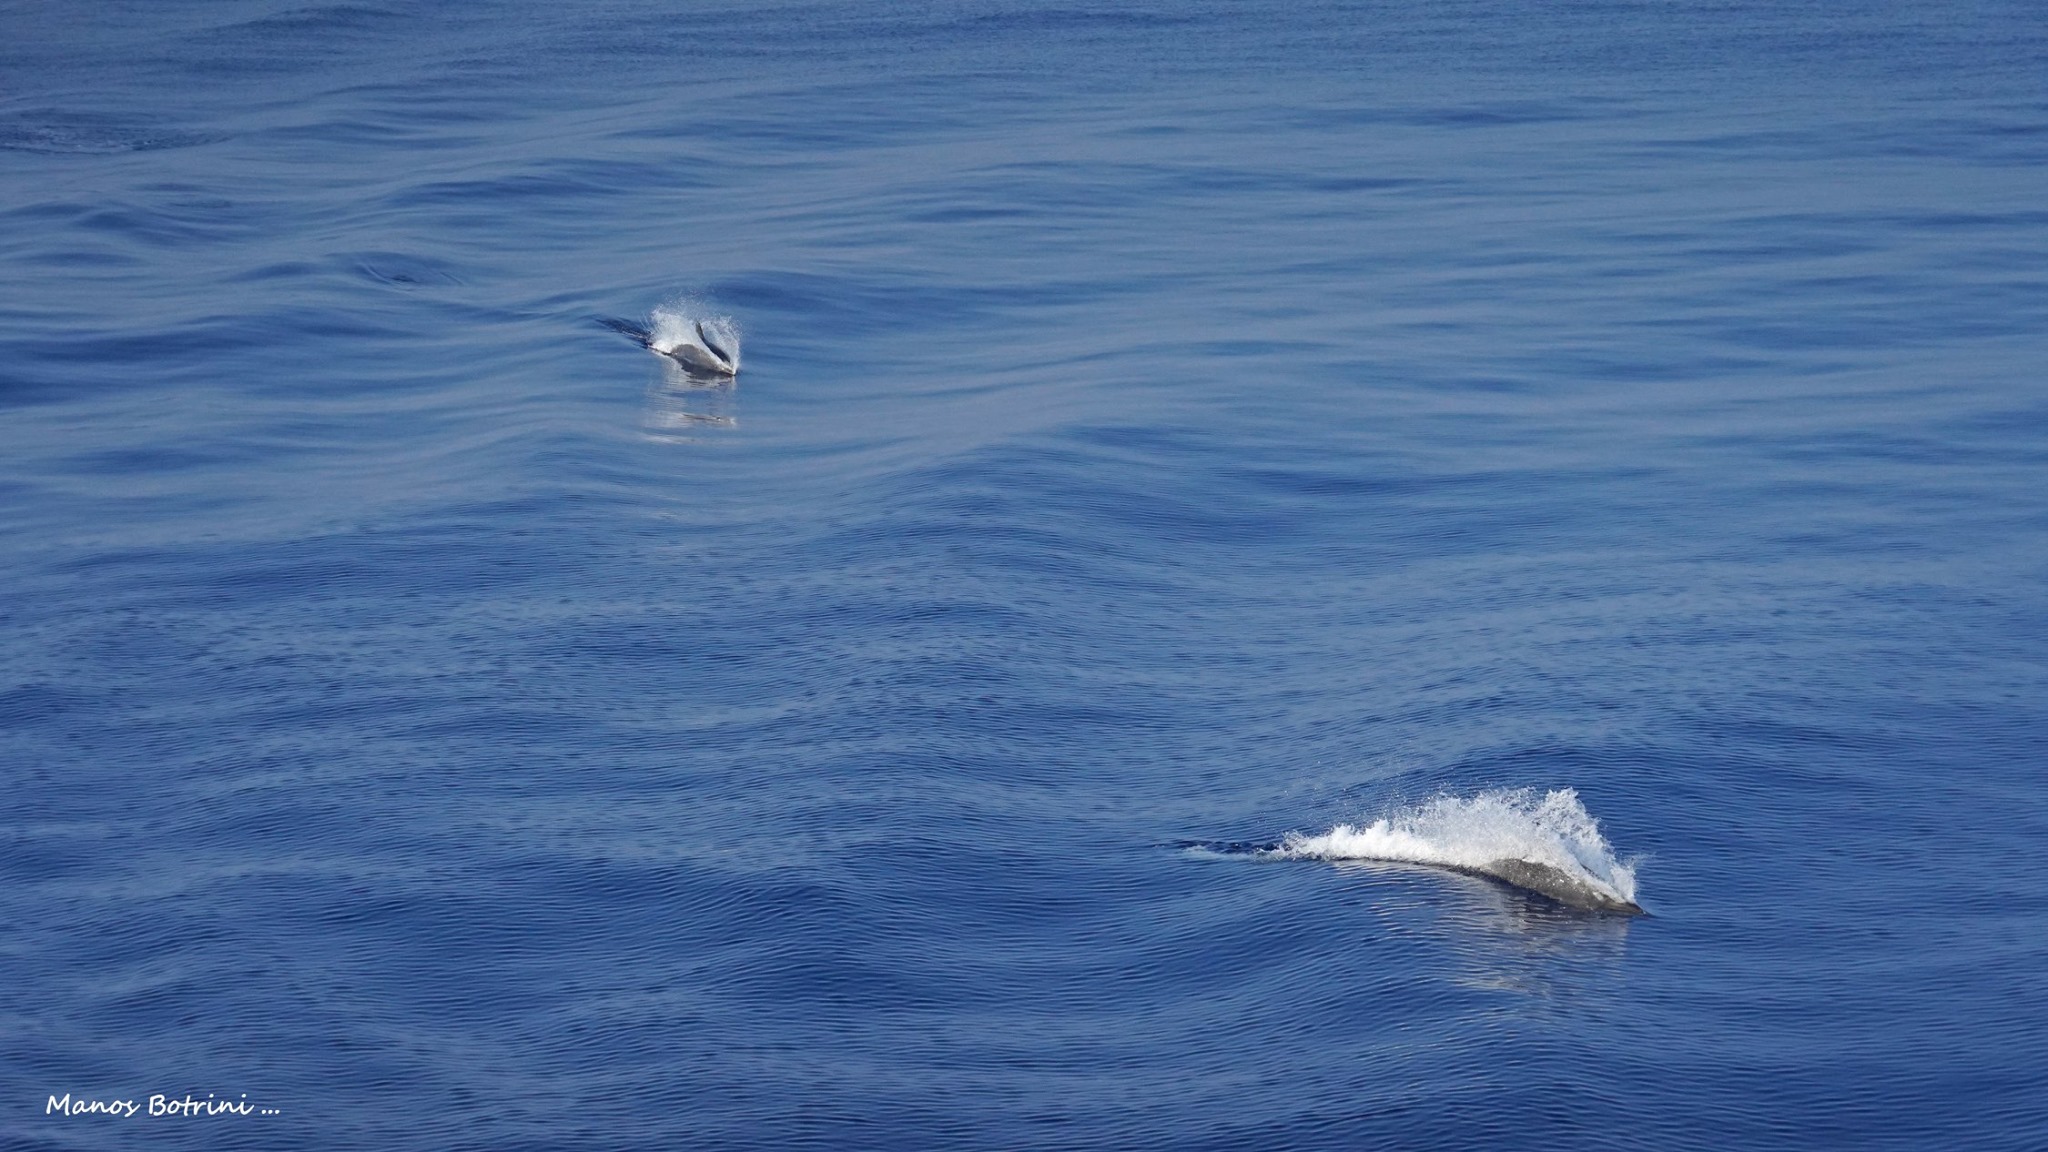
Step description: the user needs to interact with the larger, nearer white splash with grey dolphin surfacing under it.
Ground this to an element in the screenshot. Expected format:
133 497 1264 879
1266 787 1636 904
